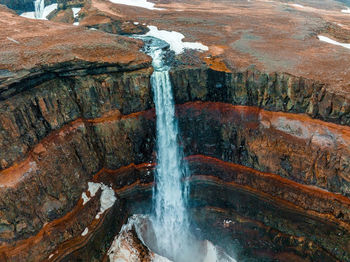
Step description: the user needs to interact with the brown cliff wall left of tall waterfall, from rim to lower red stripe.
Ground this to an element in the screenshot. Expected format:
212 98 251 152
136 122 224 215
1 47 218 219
0 68 154 241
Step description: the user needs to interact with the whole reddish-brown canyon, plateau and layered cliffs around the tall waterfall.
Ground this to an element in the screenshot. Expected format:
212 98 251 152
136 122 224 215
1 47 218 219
0 0 350 261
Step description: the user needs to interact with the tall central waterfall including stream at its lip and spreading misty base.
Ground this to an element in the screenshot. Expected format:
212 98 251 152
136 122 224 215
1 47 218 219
129 36 236 262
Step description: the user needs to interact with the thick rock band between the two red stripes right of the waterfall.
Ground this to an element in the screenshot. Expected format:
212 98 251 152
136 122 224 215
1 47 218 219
179 103 350 196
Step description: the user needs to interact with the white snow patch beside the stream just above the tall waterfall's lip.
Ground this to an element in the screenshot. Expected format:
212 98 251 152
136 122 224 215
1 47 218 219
146 26 209 54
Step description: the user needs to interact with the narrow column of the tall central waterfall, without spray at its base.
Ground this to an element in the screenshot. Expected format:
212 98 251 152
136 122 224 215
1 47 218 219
149 47 191 261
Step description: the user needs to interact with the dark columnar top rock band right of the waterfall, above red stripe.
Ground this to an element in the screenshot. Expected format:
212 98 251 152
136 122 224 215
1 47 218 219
171 66 350 125
